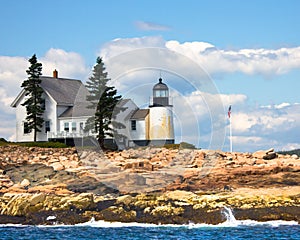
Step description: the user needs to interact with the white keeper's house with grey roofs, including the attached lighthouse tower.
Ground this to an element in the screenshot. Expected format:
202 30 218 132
11 70 174 149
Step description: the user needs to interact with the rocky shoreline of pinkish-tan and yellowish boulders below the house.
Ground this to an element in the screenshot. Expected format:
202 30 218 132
0 145 300 225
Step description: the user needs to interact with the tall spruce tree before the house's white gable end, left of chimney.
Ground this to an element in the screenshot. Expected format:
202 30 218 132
21 54 44 142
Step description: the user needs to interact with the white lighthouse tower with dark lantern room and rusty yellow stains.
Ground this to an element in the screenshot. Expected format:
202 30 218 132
149 78 174 145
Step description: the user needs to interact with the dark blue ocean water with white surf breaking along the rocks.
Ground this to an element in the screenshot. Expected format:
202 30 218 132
0 208 300 240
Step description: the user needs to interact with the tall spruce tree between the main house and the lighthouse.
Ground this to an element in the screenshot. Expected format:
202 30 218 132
86 57 122 149
